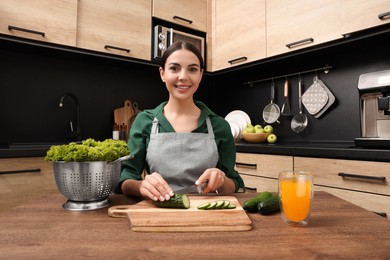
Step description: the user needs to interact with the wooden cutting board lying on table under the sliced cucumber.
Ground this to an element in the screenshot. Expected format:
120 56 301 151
108 195 252 232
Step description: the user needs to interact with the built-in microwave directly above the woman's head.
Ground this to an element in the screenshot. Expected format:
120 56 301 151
152 25 206 60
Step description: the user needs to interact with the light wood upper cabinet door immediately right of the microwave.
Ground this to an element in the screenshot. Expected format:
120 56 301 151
212 0 266 71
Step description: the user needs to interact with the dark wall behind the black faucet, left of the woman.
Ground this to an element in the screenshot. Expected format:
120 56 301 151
0 41 167 143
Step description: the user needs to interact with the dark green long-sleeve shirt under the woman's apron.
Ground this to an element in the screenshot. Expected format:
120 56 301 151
116 101 245 193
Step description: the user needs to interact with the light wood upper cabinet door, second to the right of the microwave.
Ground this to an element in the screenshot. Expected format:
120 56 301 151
266 0 342 57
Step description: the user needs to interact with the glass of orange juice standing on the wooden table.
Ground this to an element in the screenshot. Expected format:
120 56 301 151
279 171 314 226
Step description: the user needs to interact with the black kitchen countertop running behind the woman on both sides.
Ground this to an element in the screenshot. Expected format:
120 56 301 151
0 141 390 162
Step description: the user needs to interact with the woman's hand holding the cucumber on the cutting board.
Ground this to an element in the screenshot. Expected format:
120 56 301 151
139 172 174 201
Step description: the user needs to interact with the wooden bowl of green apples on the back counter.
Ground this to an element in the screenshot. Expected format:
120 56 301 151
242 124 277 144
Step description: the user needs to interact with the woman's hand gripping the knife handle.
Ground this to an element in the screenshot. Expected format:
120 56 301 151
195 168 235 194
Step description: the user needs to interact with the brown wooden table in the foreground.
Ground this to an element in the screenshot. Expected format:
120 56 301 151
0 192 390 259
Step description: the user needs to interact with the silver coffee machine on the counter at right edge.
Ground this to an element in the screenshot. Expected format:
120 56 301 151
355 70 390 149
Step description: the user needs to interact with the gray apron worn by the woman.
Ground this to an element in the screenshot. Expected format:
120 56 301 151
146 117 218 190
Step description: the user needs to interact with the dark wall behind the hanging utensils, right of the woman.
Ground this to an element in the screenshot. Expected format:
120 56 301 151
203 28 390 142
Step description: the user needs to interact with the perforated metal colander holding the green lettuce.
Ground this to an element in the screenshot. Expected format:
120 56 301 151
53 155 132 210
